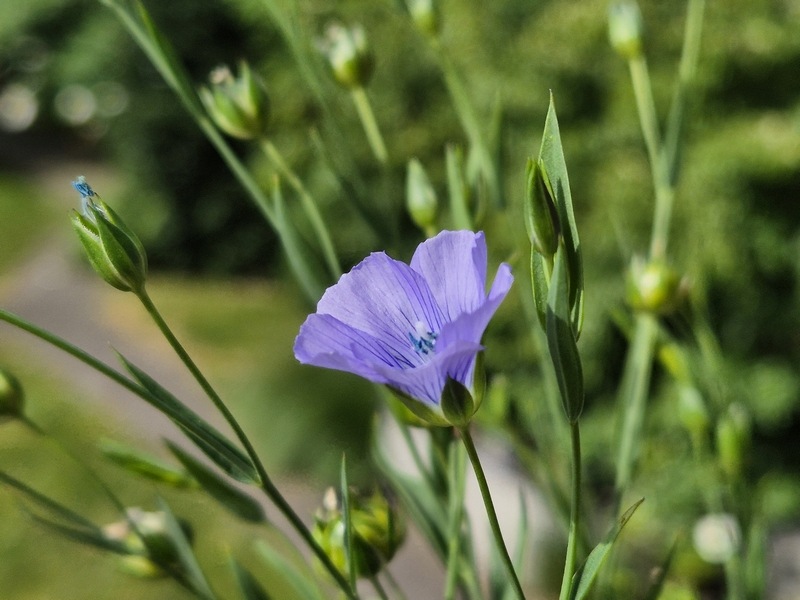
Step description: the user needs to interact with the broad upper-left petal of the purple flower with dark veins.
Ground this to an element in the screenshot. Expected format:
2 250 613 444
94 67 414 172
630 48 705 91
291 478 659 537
317 252 445 362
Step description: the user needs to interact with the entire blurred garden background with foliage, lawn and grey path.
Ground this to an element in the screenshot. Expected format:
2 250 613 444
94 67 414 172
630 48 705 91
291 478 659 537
0 0 800 599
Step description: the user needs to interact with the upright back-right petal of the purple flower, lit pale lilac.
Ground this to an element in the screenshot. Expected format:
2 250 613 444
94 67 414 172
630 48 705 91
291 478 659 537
411 231 487 321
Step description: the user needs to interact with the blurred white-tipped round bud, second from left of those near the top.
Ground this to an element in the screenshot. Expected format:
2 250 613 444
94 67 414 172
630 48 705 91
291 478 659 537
320 23 375 89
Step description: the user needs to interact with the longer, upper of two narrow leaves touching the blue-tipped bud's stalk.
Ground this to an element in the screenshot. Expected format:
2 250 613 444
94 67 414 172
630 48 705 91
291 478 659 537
118 354 259 484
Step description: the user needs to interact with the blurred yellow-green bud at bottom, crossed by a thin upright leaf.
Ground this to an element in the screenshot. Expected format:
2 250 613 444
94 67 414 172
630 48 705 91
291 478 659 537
312 488 406 577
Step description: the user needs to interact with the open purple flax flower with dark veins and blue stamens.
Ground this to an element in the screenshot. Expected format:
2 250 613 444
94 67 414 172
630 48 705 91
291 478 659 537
294 231 514 415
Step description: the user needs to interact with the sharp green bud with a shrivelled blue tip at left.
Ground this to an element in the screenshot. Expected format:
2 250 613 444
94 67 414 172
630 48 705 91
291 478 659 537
71 177 147 292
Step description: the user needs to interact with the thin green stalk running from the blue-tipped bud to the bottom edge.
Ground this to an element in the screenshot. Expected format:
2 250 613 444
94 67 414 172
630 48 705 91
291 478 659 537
137 289 358 600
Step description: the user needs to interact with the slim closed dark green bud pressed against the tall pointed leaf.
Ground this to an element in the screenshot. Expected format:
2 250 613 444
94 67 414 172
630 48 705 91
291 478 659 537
525 158 559 258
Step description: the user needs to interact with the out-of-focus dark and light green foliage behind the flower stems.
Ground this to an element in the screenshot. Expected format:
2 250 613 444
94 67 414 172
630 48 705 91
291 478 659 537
0 0 800 596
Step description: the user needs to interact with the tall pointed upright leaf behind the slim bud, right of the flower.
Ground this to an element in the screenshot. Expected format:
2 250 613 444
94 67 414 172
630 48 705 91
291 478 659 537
538 93 584 340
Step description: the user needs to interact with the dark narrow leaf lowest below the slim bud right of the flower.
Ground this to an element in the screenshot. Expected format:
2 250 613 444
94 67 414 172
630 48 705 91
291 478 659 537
545 246 583 423
